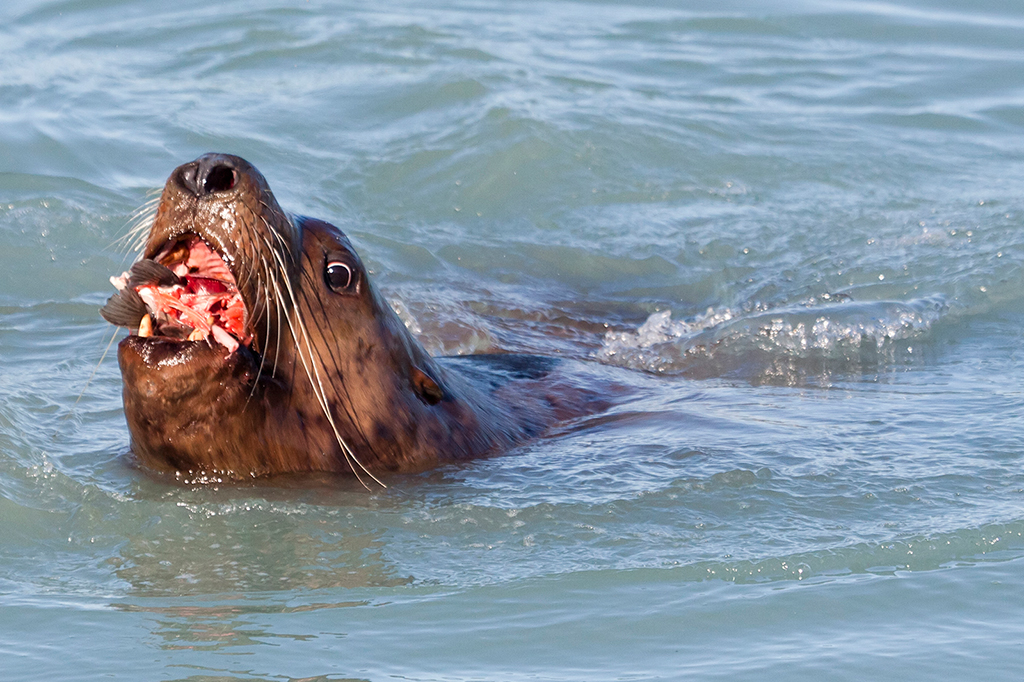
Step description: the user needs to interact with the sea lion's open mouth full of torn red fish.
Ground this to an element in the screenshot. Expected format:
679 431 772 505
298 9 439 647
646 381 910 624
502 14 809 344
99 233 252 353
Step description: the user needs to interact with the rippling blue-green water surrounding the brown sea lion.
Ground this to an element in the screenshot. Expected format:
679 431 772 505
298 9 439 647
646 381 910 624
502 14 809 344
0 0 1024 682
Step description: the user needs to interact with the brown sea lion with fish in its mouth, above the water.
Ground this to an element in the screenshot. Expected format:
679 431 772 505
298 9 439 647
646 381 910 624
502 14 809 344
100 154 593 480
